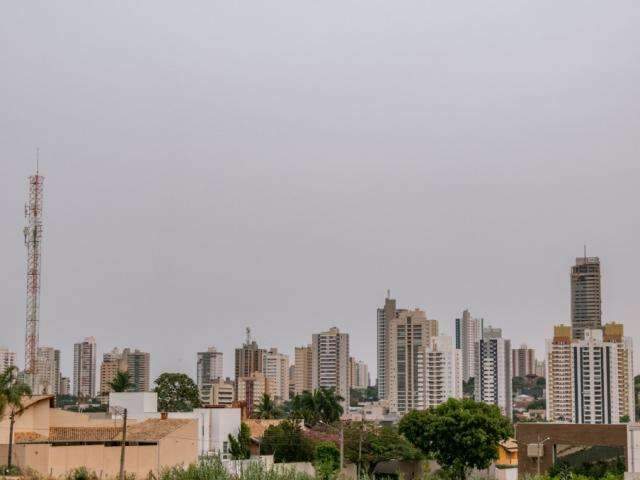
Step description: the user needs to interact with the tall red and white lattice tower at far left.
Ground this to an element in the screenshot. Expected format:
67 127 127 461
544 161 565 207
24 169 44 381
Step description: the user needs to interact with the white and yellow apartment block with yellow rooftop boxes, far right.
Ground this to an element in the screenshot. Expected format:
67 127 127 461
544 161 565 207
547 323 635 424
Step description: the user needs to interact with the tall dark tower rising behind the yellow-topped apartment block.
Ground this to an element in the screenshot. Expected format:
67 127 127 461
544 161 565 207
571 252 602 339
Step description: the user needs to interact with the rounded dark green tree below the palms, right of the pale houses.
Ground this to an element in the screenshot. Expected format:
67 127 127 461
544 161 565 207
260 420 313 463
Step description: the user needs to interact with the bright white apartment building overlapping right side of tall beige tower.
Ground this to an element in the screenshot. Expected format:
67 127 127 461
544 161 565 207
419 335 462 408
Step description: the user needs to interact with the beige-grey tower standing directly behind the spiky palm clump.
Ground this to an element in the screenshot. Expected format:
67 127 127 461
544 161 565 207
311 327 349 405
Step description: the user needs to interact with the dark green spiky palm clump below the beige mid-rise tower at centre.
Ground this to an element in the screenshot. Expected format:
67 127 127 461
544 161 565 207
290 388 344 426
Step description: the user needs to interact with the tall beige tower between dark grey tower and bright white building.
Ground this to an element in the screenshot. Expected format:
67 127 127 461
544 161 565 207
387 308 438 414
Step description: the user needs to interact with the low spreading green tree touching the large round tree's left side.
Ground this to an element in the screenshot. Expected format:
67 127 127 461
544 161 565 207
343 422 422 477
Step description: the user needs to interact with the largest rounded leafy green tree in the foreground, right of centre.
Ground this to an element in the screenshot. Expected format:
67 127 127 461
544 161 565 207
399 398 513 480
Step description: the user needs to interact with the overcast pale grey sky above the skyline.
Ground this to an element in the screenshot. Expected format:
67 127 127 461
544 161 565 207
0 0 640 377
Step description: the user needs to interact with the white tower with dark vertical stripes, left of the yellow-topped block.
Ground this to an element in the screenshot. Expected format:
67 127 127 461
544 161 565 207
474 338 513 420
